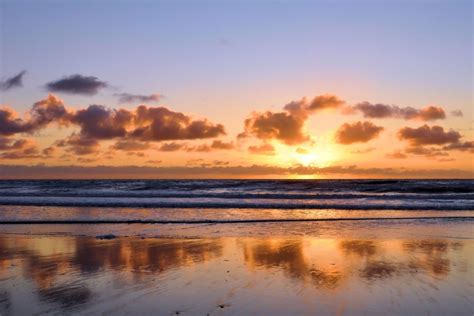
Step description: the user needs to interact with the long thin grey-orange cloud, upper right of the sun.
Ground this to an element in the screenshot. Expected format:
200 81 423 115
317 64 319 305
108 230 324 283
346 102 446 121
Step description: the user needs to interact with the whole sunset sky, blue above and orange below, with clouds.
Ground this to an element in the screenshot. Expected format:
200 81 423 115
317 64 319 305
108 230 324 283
0 0 474 178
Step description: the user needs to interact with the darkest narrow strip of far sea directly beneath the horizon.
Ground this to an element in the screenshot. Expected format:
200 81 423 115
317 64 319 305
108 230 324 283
0 180 474 194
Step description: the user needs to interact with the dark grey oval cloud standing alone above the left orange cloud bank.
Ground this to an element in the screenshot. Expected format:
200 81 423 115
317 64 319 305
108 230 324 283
46 74 107 95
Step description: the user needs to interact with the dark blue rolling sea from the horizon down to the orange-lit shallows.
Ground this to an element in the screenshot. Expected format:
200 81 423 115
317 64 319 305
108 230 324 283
0 180 474 210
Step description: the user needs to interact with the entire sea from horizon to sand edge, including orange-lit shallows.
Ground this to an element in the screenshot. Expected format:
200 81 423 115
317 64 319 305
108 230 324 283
0 180 474 224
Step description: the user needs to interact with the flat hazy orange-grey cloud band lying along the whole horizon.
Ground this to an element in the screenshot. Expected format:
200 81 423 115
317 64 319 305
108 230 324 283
0 164 474 179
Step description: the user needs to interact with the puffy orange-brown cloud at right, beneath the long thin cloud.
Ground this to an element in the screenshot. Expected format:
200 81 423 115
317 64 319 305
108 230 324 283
398 124 461 146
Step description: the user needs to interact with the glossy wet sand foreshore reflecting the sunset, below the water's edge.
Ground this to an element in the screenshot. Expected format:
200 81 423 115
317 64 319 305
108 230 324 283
0 220 474 315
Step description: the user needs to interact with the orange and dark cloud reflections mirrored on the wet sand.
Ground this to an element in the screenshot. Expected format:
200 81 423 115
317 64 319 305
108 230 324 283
0 235 472 313
